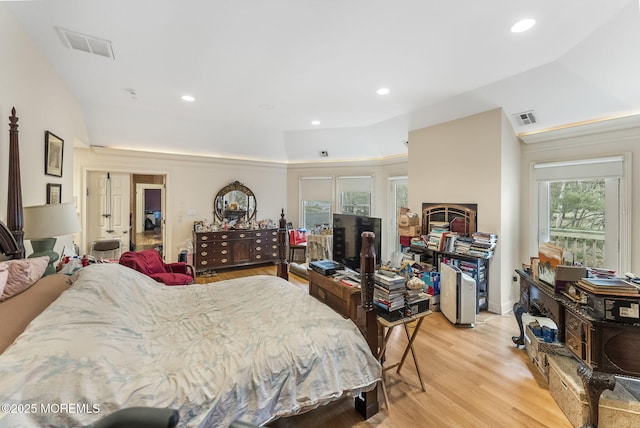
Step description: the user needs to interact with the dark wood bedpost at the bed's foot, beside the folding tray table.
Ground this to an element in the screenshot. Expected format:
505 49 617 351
355 232 380 419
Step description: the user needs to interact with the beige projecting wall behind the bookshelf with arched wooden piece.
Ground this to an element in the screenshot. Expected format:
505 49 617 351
409 109 520 313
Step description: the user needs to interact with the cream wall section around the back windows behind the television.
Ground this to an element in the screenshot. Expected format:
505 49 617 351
286 156 407 262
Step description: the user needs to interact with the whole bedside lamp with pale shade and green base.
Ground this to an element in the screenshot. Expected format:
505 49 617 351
24 202 80 275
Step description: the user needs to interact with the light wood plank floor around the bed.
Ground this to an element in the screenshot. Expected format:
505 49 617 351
197 266 571 428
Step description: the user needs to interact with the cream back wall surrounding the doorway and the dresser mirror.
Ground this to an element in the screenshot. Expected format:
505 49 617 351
74 148 287 261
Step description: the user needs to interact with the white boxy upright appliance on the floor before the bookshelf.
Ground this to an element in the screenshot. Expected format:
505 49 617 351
440 263 476 327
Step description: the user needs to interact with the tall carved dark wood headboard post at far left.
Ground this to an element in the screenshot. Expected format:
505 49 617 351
7 107 24 258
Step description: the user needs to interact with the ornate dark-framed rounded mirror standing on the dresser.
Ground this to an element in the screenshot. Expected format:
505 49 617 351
213 181 256 222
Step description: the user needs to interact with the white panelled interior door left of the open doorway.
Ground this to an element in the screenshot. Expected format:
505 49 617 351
87 171 131 244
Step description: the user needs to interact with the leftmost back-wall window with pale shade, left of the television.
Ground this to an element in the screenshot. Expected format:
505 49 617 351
300 177 333 230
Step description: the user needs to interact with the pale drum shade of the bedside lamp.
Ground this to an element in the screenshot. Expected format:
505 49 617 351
24 202 80 239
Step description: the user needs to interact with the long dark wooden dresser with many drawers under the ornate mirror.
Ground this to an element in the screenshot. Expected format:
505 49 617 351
193 229 278 273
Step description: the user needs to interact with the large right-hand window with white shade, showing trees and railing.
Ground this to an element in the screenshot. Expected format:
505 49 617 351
534 156 630 272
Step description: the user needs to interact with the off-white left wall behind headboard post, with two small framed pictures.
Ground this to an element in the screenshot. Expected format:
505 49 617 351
0 4 88 253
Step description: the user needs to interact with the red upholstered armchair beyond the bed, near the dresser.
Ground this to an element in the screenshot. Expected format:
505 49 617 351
120 249 195 285
